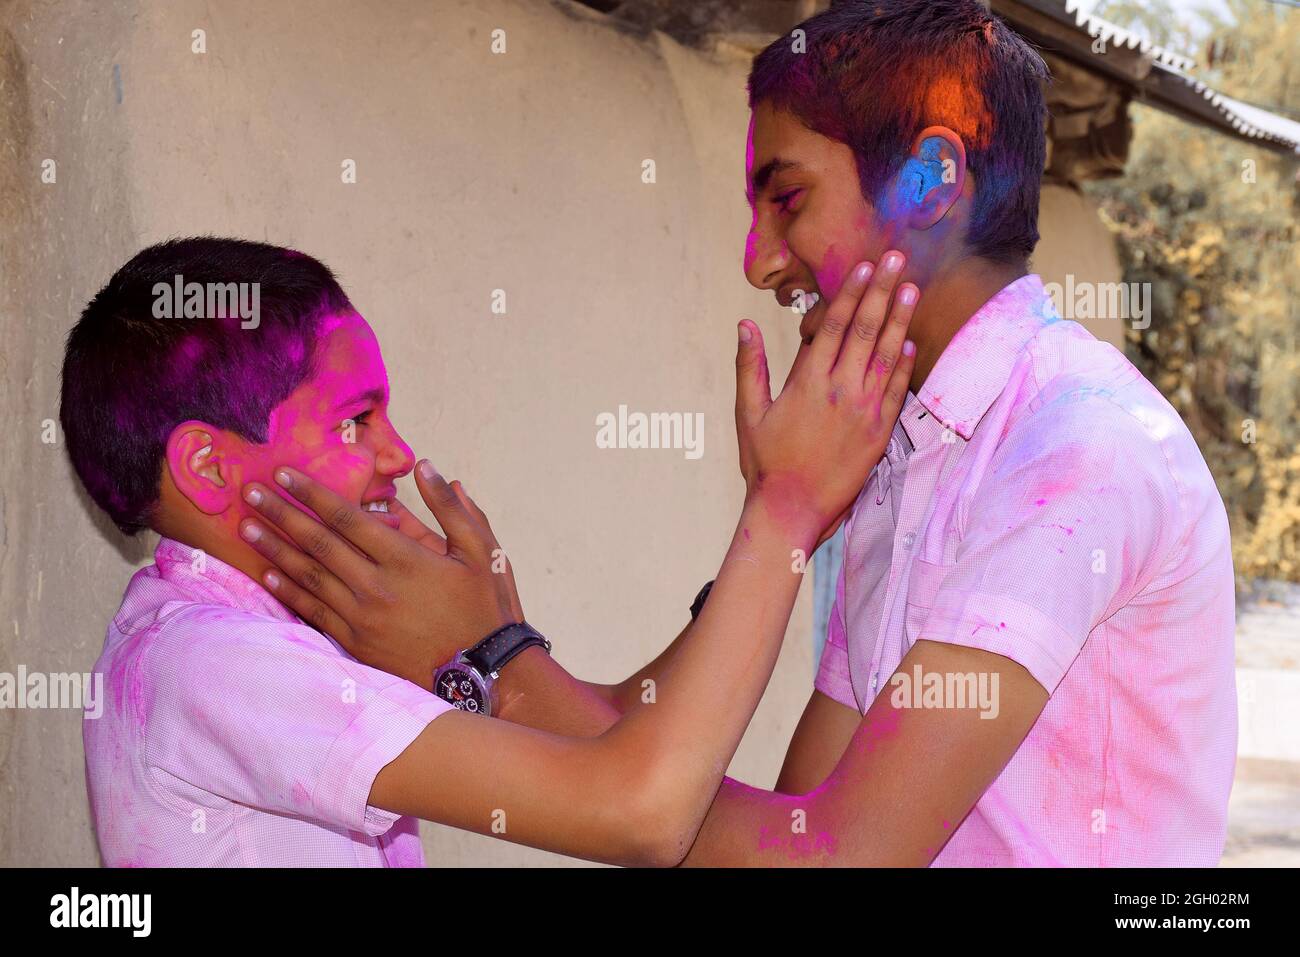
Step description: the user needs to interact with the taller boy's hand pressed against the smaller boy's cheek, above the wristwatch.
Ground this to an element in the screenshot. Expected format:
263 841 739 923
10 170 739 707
241 463 524 688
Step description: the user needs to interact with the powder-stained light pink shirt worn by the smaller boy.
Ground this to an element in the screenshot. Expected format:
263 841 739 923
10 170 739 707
82 538 450 867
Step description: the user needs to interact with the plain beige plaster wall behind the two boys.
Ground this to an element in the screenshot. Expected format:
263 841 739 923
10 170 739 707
0 0 1118 865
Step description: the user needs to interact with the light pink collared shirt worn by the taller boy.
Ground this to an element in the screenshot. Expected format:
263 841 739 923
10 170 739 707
816 276 1236 866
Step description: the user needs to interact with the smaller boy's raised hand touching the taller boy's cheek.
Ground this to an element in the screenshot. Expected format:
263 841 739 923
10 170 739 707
736 252 919 544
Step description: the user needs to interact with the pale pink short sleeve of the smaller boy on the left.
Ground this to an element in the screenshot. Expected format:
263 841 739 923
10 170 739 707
140 605 451 836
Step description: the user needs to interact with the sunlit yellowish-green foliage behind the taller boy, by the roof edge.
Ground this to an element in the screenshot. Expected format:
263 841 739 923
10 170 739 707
1088 0 1300 584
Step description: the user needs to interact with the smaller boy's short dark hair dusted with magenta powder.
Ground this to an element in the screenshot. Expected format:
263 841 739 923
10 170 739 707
59 237 352 534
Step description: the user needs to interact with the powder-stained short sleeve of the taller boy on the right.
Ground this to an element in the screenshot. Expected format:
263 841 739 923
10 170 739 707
920 395 1182 693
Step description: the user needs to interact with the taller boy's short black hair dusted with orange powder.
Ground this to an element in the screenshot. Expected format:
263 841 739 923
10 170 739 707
749 0 1048 265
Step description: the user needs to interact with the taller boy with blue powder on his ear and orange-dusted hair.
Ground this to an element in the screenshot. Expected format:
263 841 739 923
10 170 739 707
253 0 1236 866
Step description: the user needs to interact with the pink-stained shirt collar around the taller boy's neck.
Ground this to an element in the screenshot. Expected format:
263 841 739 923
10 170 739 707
909 273 1060 443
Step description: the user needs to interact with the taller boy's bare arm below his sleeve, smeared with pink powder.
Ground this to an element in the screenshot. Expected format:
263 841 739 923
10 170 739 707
686 638 1048 867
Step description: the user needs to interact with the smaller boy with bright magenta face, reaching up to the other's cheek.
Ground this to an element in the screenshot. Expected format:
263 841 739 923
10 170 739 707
60 238 915 866
